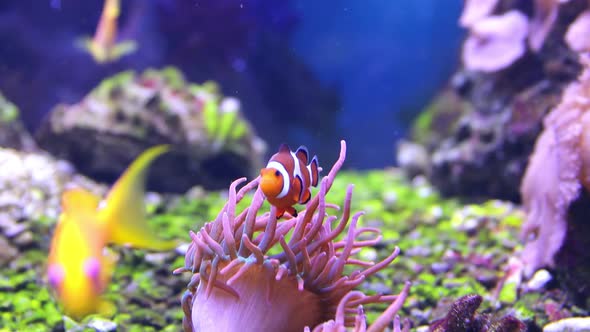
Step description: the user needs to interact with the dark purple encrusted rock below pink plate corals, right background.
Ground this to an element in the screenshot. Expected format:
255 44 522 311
426 82 558 201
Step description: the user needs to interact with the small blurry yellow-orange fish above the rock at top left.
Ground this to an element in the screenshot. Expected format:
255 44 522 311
78 0 137 63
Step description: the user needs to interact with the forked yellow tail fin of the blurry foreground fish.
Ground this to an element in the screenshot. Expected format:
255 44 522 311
99 145 177 250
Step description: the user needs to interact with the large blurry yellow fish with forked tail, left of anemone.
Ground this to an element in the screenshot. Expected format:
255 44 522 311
47 145 177 320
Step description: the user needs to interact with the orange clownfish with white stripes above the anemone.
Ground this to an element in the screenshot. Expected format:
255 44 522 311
260 144 321 219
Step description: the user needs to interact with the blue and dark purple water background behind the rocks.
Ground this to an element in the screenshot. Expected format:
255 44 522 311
0 0 464 168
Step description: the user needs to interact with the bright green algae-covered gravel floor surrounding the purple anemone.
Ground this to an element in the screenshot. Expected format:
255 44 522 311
0 169 583 331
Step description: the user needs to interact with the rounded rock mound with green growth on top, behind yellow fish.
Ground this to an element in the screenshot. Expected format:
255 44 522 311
37 67 265 192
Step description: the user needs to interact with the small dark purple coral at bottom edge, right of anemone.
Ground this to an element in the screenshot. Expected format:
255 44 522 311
430 294 526 332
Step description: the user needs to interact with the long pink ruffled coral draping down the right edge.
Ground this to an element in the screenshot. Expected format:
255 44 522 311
521 55 590 276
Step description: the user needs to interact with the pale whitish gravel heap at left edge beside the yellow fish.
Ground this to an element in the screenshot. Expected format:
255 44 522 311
0 148 106 267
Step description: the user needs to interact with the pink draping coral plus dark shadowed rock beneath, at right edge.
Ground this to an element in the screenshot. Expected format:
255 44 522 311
520 54 590 296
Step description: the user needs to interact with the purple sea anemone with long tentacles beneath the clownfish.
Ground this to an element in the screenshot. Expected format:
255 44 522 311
175 141 410 332
